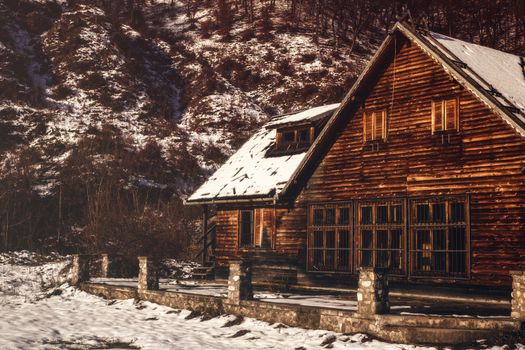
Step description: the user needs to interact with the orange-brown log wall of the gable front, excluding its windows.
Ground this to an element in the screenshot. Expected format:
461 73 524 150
298 40 525 285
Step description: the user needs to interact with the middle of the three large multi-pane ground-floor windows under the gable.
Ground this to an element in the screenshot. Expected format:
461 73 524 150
356 201 406 274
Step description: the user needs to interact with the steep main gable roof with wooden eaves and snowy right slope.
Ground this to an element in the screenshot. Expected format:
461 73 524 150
281 22 525 199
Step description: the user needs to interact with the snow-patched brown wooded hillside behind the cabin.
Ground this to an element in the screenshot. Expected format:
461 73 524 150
0 0 525 258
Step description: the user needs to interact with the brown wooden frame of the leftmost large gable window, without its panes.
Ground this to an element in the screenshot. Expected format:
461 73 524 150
306 201 355 274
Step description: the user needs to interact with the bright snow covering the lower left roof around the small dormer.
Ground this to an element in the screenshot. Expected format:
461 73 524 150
188 104 339 202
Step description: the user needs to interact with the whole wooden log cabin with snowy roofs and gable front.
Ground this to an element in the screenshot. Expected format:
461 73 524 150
188 23 525 286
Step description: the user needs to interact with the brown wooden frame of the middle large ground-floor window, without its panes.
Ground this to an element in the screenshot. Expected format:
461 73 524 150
354 198 408 277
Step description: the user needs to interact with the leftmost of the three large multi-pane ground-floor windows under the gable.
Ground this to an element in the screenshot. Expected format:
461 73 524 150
308 203 352 272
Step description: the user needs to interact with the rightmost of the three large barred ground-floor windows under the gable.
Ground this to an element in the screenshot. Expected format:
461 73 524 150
411 198 469 277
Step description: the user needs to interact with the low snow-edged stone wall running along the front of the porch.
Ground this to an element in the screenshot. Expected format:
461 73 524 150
80 282 521 345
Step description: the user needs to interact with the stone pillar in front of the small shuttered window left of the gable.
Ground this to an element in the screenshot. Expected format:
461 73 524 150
228 260 253 305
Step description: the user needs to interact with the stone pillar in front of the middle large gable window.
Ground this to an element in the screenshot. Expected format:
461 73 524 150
357 267 390 316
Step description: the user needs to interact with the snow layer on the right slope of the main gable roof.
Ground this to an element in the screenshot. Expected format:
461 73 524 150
427 32 525 121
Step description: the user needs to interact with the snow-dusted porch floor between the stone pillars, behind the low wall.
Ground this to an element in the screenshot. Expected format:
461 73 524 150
91 278 510 318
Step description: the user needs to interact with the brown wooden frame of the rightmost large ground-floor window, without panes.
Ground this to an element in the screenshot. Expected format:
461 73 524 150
408 195 472 281
